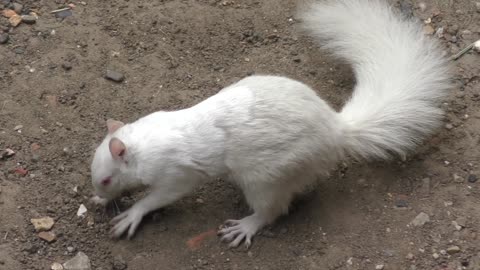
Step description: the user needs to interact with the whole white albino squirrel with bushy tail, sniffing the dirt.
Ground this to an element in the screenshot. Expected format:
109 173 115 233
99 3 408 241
92 0 451 247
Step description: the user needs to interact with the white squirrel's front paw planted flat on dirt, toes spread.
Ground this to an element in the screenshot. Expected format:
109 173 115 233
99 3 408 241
110 208 144 239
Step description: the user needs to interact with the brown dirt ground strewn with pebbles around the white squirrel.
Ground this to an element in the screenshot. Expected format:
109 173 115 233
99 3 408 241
0 0 480 270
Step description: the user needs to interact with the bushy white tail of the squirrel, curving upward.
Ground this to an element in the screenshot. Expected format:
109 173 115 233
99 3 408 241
301 0 451 158
